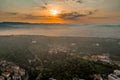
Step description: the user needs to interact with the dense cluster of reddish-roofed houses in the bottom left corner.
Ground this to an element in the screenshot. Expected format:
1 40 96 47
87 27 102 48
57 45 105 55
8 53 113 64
0 60 26 80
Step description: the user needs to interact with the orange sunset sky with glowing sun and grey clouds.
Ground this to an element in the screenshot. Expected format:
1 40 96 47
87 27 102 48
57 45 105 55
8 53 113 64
0 0 120 23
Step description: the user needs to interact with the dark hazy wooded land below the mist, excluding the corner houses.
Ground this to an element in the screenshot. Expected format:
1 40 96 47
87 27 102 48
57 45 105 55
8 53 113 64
0 36 120 80
